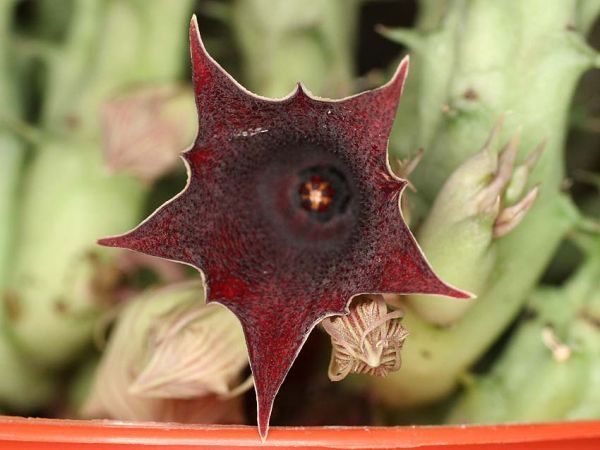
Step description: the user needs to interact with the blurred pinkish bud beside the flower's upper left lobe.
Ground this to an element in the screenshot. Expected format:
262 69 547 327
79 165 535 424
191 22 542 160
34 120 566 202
102 86 197 181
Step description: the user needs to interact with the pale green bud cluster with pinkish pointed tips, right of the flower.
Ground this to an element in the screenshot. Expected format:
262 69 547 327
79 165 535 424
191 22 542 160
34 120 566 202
408 120 541 325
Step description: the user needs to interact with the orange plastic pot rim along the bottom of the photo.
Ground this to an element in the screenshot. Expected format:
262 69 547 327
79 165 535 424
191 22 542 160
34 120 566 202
0 416 600 450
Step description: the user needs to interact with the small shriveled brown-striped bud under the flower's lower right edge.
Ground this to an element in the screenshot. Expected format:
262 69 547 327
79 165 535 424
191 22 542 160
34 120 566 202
321 295 408 381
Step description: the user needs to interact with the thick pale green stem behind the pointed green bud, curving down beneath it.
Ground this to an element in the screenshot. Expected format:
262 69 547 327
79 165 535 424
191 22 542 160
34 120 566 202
368 0 597 408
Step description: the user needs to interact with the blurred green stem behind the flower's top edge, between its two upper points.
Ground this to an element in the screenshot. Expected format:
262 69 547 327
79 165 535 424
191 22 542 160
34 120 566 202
231 0 360 98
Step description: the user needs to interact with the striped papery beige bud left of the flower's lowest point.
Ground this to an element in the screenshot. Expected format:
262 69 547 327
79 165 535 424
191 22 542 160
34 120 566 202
129 298 252 398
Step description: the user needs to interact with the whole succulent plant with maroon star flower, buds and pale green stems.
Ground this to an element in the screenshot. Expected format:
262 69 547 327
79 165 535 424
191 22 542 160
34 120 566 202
0 0 600 437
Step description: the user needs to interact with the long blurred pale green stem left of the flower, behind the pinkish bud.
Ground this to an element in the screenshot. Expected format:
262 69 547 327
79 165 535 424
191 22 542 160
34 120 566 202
5 0 192 378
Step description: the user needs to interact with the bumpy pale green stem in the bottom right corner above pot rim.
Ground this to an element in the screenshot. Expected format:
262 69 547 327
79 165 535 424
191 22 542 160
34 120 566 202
447 248 600 423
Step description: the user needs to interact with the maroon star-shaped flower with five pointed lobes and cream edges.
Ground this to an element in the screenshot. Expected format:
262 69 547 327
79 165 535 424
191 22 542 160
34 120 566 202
101 21 467 437
